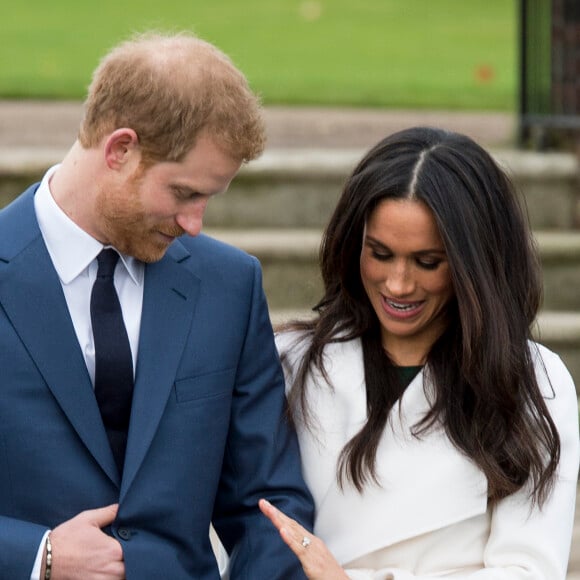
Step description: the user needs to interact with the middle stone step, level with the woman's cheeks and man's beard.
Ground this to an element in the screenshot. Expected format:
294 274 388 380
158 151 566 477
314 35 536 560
205 228 580 311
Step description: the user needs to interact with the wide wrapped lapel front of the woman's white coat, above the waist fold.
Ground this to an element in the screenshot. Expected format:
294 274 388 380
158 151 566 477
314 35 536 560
290 340 487 563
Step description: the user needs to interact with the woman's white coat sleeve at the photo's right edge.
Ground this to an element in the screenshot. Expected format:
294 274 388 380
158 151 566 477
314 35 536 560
347 349 580 580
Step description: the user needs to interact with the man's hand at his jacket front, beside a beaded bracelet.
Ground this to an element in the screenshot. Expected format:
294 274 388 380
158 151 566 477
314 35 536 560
40 504 125 580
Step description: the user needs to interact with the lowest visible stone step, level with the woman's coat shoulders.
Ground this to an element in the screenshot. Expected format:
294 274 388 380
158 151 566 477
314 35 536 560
270 308 580 398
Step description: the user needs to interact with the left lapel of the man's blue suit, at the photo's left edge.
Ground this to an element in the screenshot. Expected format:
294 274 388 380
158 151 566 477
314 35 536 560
0 192 119 484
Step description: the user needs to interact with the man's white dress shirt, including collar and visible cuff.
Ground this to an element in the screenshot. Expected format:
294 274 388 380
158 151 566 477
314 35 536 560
30 165 145 580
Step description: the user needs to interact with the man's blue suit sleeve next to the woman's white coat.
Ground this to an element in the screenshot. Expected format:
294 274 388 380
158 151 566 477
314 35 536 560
213 259 313 580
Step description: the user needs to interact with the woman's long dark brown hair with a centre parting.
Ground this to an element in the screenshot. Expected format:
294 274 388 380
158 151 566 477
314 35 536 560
290 127 560 504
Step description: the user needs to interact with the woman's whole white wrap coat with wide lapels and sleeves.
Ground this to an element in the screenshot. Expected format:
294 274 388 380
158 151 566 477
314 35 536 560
277 333 579 580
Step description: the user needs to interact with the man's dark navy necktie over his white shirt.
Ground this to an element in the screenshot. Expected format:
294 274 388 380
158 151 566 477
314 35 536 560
91 249 133 473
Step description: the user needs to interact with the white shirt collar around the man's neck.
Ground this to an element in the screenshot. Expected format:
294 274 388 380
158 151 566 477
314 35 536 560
34 165 145 286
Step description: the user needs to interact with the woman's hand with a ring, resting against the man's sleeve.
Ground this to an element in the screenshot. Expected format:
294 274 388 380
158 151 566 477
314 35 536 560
259 499 348 580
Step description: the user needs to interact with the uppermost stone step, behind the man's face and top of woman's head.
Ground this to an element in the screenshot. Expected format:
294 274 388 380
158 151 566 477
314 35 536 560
0 148 580 229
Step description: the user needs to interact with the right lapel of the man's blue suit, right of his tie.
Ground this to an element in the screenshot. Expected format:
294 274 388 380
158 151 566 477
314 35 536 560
121 242 199 499
